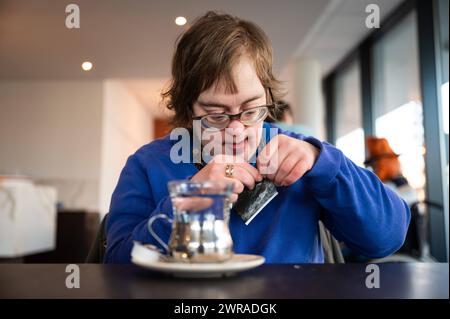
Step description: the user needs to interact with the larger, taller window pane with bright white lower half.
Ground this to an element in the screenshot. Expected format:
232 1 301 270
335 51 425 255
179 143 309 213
372 12 426 198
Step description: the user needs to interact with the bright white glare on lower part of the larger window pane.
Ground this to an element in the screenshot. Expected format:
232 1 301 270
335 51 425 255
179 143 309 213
375 101 425 196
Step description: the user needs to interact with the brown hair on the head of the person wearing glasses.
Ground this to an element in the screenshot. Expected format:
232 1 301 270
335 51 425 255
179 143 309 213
162 11 283 127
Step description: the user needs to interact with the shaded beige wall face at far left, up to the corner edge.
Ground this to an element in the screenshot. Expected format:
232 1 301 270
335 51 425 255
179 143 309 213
0 80 103 209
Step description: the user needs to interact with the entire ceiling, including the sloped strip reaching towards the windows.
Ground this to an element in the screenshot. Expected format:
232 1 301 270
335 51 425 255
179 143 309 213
0 0 401 115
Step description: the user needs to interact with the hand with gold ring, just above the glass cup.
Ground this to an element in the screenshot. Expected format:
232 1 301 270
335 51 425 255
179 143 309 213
191 155 263 203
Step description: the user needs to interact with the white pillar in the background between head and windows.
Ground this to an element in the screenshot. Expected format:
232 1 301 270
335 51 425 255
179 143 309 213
292 58 325 139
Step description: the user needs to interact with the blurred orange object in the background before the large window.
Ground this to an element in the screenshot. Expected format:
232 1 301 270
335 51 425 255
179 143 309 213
364 136 402 182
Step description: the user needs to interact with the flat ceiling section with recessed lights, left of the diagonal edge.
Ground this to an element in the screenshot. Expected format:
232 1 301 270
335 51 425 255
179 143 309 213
0 0 329 78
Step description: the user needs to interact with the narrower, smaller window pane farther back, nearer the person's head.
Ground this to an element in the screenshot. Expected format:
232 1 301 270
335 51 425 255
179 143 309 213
335 60 365 166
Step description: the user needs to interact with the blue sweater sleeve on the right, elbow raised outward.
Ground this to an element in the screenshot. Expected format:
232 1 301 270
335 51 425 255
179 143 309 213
274 126 410 258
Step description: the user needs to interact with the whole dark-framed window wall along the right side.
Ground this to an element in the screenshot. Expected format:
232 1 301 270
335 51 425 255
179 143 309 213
324 0 449 261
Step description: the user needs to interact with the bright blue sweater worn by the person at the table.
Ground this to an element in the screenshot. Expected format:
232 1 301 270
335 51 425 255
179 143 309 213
104 123 410 263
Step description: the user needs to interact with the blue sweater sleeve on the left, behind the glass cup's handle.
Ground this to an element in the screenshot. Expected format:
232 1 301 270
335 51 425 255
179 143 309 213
104 153 172 263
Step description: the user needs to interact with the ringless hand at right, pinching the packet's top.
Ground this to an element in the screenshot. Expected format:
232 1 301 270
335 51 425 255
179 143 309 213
256 134 320 186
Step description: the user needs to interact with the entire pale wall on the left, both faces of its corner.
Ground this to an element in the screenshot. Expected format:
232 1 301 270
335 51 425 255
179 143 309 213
0 80 153 214
